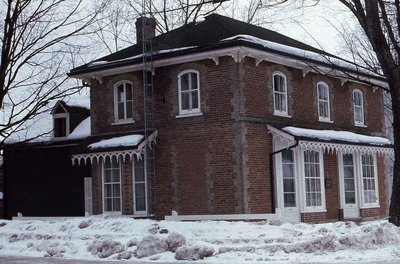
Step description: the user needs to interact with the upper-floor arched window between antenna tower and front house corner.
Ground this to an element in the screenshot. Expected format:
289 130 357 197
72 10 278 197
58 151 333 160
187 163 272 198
178 70 200 115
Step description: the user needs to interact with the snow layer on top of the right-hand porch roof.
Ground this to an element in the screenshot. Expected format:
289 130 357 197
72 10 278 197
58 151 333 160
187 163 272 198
282 126 390 145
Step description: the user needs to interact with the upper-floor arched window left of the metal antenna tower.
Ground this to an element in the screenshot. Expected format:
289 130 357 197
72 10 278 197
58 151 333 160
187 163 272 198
114 81 133 122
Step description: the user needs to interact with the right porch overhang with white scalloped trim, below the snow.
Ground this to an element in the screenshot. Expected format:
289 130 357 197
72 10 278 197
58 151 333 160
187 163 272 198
267 125 394 155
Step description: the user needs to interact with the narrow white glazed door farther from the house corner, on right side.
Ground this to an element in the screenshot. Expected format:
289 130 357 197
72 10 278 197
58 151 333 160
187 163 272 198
340 154 360 219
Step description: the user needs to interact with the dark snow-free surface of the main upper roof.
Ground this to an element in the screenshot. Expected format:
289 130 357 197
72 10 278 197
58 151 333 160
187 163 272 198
70 14 335 75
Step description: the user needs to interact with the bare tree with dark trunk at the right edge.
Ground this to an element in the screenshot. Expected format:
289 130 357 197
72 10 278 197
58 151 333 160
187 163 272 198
324 0 400 226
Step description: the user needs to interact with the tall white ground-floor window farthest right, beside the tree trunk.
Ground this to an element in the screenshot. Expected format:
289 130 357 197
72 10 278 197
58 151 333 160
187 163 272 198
361 154 378 205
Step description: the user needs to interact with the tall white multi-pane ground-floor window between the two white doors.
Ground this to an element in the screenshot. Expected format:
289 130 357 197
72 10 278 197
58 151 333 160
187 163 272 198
304 150 324 209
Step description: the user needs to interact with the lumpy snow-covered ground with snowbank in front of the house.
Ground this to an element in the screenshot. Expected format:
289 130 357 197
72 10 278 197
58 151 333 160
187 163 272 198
0 216 400 263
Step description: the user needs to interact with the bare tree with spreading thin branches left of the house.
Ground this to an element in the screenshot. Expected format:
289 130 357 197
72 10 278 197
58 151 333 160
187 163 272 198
0 0 108 141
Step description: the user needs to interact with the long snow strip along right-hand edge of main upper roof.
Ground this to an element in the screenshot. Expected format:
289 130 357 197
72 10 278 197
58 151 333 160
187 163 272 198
222 35 382 78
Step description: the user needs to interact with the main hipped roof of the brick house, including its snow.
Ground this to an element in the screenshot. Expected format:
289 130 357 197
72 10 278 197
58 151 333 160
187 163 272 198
69 14 384 84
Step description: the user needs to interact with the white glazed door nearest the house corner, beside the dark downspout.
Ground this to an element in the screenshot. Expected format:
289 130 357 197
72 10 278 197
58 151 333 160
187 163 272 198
277 149 300 222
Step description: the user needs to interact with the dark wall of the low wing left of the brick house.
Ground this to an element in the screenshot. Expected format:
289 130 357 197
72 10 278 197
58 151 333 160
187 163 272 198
4 145 90 218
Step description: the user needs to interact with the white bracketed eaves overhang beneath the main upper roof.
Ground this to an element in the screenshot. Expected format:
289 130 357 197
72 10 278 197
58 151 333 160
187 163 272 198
69 40 388 88
